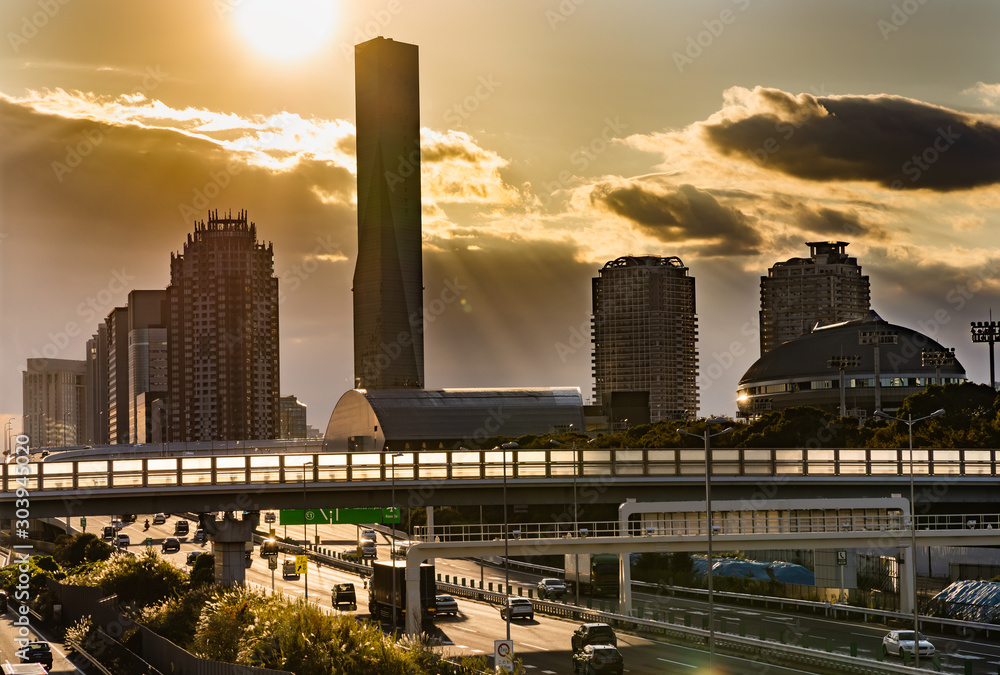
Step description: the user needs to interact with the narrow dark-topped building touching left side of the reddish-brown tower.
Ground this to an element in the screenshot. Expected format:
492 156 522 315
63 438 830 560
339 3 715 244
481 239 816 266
128 290 169 443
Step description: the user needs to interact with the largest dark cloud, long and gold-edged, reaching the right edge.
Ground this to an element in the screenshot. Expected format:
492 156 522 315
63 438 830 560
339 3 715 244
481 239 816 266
703 87 1000 192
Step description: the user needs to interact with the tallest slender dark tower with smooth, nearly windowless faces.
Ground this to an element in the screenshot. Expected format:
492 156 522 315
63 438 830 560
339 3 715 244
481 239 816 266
353 37 424 389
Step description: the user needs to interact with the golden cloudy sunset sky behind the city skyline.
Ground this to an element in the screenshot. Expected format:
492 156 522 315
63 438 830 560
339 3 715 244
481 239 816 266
0 0 1000 429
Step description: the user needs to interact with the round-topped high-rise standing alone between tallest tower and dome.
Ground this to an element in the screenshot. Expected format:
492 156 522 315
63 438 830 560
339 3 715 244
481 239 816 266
592 256 698 429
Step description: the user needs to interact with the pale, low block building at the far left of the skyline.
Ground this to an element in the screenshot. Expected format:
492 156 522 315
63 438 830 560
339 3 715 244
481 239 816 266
21 359 87 448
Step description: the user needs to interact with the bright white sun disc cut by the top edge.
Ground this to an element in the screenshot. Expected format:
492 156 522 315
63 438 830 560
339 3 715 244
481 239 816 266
234 0 334 61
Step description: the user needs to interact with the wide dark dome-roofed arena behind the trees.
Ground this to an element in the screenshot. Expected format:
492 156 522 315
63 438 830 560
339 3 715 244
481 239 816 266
737 311 966 418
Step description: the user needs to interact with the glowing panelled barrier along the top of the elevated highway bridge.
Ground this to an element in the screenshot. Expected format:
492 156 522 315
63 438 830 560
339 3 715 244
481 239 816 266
0 446 1000 492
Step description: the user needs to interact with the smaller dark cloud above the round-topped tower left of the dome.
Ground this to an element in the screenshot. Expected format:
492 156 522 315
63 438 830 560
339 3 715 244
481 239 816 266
590 182 761 255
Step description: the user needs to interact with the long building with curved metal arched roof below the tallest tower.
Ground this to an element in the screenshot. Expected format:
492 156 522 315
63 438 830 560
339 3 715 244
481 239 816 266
324 387 585 452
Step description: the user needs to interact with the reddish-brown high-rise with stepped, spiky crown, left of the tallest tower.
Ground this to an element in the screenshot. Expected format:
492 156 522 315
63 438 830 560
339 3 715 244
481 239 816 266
167 211 279 441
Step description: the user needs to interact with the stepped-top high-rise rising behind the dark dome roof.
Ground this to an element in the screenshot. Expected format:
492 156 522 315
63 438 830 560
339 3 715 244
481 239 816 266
760 241 871 356
